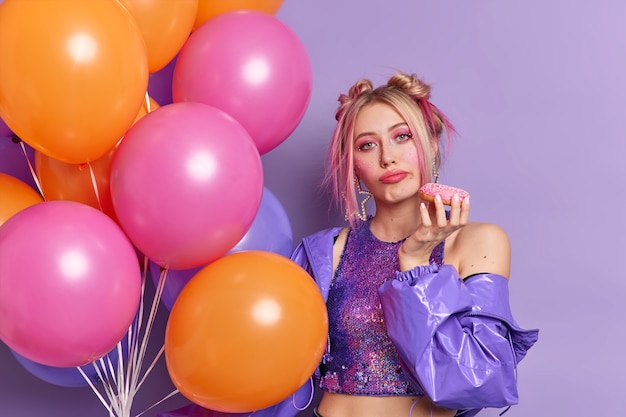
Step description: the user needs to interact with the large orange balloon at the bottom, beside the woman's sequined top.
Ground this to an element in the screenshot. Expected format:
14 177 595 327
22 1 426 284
165 251 328 413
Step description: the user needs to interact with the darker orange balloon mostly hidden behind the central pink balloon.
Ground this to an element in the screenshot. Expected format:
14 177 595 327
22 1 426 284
35 98 159 222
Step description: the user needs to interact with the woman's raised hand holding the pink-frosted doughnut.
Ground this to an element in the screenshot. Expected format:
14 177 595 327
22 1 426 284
398 194 470 271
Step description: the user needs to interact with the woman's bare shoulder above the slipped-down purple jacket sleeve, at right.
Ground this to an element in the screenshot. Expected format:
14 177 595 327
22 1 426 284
452 222 511 278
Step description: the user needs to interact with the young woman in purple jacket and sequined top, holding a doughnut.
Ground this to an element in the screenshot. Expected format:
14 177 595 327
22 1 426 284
277 73 538 417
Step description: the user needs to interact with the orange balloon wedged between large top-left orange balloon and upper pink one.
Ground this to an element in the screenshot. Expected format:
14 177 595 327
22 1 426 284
119 0 198 73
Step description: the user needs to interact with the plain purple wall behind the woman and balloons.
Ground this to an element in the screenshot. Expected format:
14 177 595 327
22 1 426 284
0 0 626 417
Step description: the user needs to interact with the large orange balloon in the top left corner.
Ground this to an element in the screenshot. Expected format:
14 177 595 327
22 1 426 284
0 0 149 164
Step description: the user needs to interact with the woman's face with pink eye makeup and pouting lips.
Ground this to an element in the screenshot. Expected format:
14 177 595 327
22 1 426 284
353 102 421 204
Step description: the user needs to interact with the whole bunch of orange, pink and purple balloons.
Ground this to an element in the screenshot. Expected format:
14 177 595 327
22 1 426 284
0 0 327 413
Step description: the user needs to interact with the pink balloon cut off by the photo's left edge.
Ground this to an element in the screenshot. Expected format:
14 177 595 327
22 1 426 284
0 200 141 367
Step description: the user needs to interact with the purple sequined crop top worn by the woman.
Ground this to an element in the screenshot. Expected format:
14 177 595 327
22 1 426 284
320 220 443 396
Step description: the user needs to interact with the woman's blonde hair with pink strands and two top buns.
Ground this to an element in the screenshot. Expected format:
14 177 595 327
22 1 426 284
324 73 454 225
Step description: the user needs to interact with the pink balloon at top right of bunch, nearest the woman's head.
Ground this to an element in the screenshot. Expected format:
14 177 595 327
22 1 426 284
172 10 312 155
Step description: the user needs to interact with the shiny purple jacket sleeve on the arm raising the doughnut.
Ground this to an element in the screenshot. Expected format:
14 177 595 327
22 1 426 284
379 264 538 415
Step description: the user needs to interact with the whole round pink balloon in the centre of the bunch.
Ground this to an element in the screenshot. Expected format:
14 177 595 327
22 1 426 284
111 103 263 269
